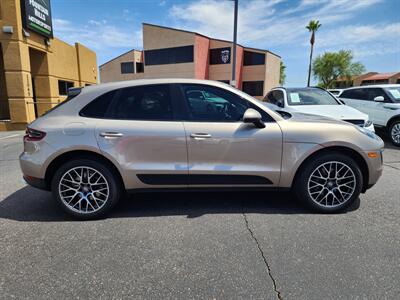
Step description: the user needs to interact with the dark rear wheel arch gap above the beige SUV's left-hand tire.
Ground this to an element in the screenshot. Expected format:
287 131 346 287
44 150 125 190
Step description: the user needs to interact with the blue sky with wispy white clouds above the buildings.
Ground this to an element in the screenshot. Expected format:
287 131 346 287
51 0 400 86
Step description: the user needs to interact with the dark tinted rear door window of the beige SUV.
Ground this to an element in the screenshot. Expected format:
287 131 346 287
110 84 173 120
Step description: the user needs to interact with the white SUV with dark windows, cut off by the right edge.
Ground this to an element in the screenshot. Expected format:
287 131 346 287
339 84 400 147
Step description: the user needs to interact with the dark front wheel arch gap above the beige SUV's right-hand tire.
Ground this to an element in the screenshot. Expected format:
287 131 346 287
292 146 369 193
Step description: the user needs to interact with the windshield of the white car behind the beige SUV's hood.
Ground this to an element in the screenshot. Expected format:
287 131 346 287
287 88 340 105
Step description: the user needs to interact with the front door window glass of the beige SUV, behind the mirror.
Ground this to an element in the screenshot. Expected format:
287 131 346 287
182 84 271 122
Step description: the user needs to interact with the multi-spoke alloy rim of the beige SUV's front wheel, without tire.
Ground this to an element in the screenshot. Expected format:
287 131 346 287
307 161 356 208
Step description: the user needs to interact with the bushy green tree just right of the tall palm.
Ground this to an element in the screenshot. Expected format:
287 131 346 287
313 50 365 89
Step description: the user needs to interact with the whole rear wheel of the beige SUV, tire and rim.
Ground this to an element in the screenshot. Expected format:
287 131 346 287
51 158 122 220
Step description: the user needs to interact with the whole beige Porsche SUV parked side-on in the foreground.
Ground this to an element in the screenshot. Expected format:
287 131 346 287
20 79 383 219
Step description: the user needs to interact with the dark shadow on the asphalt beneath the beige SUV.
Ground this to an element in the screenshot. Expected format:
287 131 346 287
0 186 360 222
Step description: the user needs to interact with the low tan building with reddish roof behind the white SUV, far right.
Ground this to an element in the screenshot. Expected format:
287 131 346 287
335 72 400 89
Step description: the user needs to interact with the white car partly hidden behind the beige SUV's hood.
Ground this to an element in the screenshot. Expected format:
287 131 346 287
264 87 375 131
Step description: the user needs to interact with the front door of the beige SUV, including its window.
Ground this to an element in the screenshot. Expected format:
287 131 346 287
181 84 282 187
